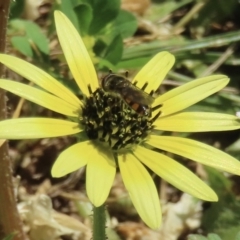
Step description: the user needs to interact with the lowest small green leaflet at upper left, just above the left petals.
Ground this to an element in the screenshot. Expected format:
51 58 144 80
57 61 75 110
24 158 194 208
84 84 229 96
11 36 33 57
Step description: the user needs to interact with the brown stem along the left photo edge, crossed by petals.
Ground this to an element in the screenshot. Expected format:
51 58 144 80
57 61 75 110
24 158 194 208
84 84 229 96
0 0 24 240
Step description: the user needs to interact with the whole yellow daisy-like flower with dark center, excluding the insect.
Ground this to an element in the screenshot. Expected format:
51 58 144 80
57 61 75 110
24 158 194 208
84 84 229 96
0 12 240 228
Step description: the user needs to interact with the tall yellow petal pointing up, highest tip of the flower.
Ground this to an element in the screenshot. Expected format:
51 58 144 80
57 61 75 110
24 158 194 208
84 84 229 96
54 11 99 96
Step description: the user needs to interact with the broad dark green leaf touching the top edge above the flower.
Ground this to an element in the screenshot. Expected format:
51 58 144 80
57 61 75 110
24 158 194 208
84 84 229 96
88 0 120 35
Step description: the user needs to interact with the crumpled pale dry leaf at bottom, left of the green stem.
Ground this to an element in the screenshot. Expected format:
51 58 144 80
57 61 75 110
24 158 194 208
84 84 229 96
19 194 91 240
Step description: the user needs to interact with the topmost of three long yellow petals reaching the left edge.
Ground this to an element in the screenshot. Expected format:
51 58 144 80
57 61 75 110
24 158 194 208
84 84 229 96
0 54 82 108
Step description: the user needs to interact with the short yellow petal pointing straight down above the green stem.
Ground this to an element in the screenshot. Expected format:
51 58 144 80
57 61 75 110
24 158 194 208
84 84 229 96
84 145 116 207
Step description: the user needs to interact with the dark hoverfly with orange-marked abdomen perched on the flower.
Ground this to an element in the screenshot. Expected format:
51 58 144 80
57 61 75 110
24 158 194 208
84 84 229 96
102 73 154 116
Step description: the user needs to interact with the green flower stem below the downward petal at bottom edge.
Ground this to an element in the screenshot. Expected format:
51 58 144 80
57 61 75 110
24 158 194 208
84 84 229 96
93 205 106 240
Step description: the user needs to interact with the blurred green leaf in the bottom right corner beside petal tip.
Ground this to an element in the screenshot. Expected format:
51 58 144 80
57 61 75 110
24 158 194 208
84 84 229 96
202 167 240 240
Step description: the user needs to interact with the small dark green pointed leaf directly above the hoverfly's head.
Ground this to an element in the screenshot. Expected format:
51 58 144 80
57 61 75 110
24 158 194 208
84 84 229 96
104 35 123 64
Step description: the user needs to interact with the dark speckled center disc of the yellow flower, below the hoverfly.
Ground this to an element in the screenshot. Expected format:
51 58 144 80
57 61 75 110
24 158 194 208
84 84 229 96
80 88 155 150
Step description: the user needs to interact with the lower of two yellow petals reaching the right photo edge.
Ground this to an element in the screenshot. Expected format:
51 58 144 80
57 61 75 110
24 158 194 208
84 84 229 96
147 135 240 175
